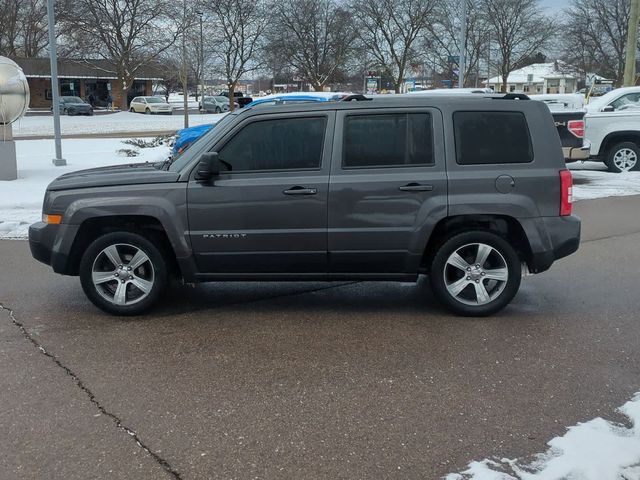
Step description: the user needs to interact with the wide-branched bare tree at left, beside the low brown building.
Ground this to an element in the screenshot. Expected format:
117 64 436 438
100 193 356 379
60 0 184 109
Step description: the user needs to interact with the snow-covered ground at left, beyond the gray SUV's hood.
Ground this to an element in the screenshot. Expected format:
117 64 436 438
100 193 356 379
0 138 169 238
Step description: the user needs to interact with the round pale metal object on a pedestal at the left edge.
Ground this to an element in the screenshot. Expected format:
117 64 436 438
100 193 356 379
0 57 30 125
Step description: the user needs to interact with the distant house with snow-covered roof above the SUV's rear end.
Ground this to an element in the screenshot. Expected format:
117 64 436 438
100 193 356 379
483 60 582 95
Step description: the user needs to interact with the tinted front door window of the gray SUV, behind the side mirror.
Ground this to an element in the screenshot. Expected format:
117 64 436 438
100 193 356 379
218 117 327 172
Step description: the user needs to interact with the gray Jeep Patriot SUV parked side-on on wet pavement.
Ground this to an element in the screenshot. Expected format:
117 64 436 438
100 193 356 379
29 95 580 316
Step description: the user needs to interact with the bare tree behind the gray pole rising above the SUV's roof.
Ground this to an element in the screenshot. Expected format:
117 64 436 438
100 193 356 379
425 0 490 85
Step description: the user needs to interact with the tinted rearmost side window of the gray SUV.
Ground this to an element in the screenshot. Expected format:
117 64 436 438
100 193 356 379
453 112 533 165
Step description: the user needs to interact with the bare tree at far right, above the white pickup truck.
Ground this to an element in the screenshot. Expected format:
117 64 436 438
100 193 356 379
563 0 629 84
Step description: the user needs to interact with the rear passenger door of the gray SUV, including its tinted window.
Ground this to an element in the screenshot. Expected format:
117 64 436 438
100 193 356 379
329 108 447 277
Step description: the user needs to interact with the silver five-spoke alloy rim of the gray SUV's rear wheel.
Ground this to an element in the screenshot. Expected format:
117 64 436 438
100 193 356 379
443 243 509 305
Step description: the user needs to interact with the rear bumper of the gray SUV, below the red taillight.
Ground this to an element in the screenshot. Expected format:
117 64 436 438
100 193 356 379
529 215 581 273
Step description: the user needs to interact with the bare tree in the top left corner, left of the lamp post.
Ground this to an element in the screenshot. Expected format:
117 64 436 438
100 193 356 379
0 0 48 58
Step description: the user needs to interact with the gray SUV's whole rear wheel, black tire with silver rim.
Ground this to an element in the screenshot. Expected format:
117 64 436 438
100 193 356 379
429 230 522 317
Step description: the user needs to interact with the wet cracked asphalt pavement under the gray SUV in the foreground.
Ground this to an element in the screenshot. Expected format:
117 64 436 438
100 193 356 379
0 197 640 480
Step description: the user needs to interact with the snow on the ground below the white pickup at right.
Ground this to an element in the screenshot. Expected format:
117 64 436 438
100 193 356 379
569 162 640 201
